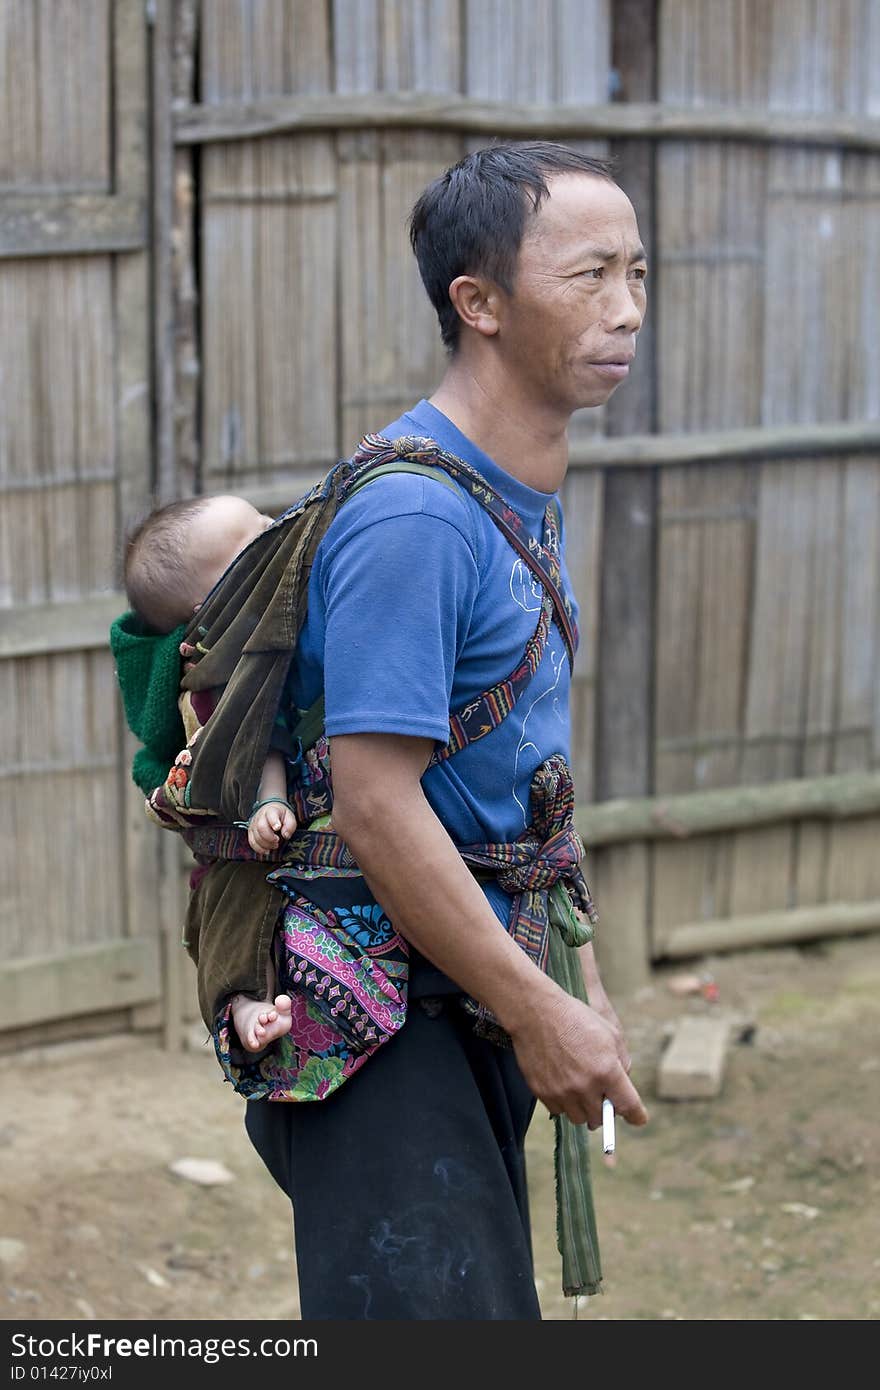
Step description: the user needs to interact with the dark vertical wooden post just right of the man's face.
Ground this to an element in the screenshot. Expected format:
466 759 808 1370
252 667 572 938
595 0 656 992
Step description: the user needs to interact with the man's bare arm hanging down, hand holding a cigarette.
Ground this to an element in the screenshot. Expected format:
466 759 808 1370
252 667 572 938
331 734 648 1129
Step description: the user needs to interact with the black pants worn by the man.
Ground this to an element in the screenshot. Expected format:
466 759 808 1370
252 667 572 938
245 997 541 1321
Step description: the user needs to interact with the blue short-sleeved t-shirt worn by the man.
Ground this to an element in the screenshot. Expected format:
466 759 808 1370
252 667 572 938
287 400 573 956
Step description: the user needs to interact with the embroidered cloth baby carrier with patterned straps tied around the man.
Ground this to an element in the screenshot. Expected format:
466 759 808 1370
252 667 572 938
114 435 601 1291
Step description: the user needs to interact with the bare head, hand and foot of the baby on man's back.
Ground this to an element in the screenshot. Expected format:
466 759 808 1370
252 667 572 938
125 496 296 1052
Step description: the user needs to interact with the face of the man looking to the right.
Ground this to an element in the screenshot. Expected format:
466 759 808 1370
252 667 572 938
498 174 646 417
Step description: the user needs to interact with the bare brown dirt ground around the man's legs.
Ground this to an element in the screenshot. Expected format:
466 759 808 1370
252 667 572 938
0 935 880 1322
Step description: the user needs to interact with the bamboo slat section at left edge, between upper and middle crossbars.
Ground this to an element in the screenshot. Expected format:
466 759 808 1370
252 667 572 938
0 257 115 603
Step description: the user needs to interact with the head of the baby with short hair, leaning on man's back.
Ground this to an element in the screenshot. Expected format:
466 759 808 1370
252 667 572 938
125 496 272 632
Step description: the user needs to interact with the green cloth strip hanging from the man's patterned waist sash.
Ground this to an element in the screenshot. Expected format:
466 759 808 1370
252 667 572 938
548 883 602 1297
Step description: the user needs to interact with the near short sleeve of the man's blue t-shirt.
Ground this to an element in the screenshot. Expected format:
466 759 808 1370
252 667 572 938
323 484 478 742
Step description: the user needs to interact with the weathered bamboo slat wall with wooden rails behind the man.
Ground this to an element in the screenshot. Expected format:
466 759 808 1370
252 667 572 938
0 0 880 1045
